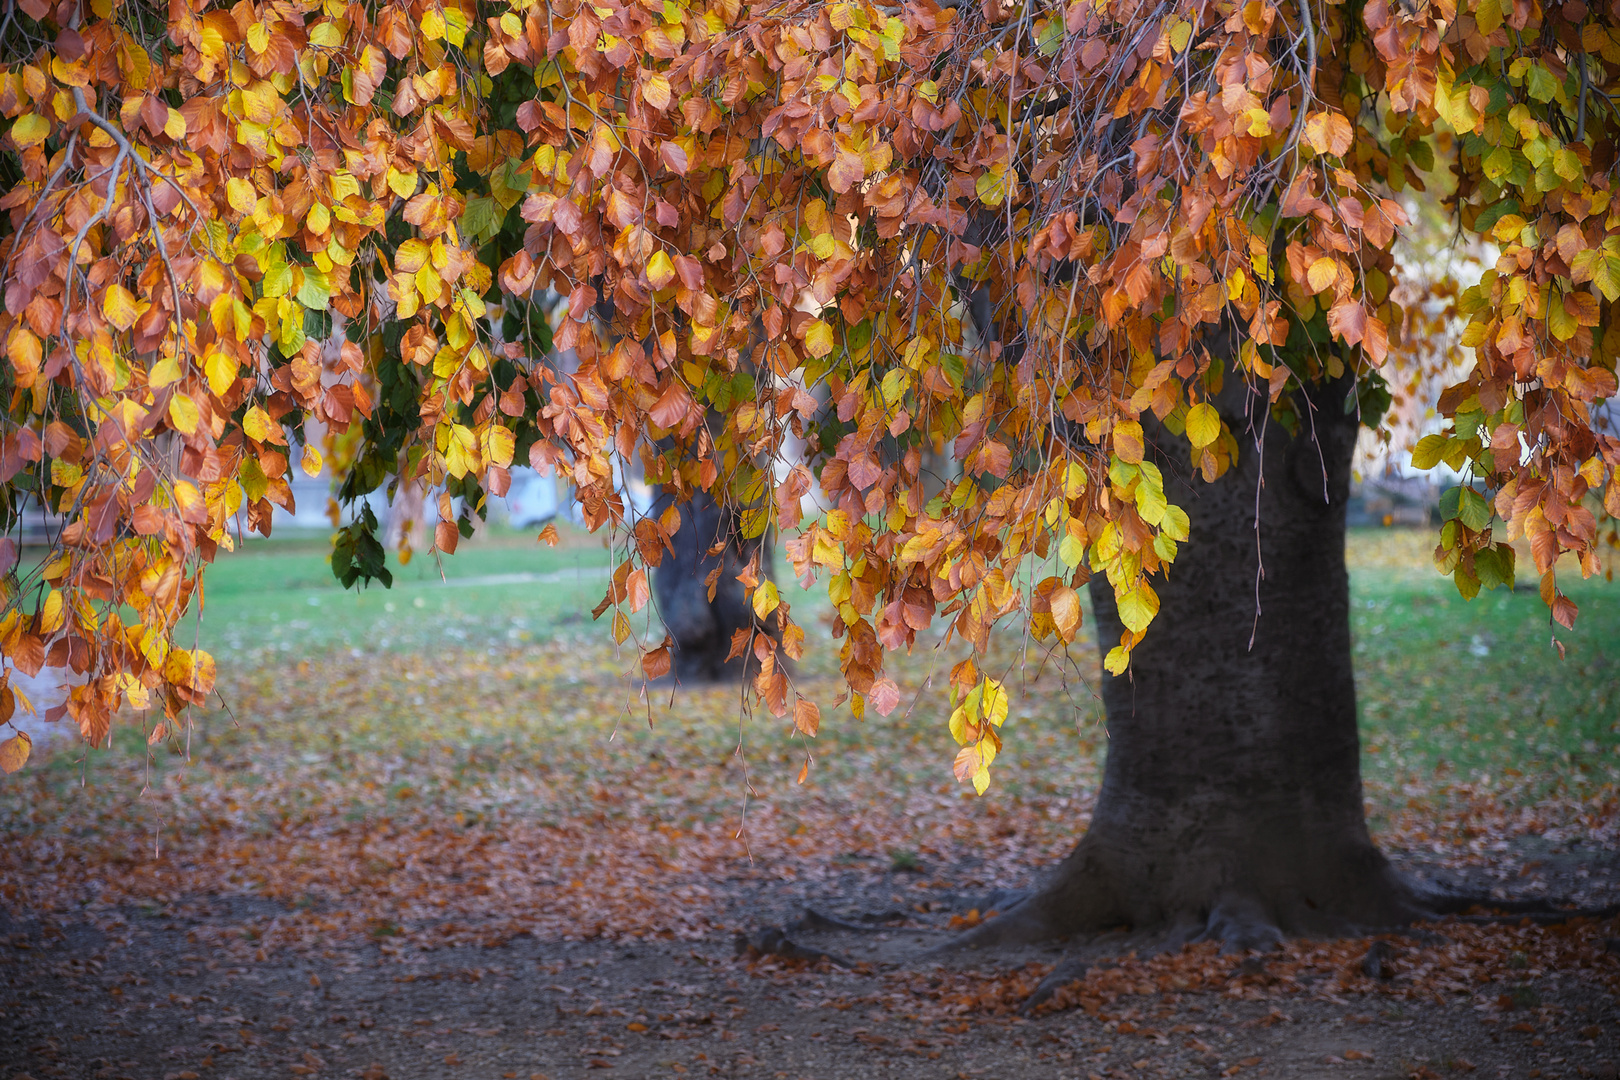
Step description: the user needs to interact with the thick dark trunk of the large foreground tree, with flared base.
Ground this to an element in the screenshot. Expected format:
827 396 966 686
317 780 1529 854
970 377 1434 949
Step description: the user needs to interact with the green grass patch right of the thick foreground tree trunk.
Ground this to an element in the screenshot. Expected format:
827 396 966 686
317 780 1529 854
1351 531 1620 803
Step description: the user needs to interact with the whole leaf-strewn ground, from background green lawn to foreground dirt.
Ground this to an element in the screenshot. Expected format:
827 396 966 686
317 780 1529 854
0 531 1620 1080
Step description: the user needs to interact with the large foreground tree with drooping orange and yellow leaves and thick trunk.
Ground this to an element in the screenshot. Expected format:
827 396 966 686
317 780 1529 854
0 0 1620 942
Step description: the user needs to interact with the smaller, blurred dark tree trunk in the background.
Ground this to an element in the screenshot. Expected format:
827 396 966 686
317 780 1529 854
653 491 773 683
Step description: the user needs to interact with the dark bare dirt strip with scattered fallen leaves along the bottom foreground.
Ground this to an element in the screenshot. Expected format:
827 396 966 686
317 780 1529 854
0 853 1620 1080
